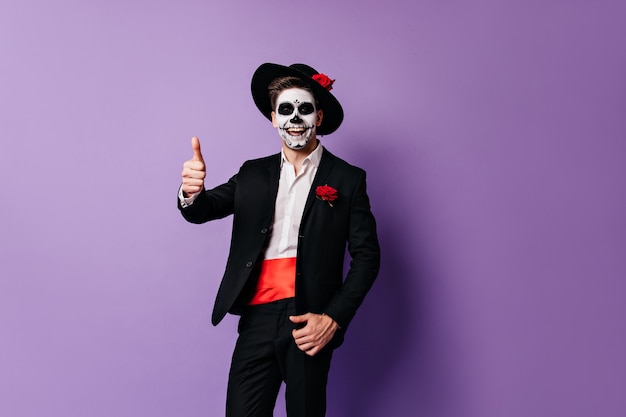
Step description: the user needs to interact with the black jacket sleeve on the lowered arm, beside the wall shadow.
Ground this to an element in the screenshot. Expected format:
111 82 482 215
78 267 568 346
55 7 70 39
324 171 380 330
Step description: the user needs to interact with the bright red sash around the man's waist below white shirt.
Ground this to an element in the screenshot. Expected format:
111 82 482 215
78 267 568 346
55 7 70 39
249 257 296 305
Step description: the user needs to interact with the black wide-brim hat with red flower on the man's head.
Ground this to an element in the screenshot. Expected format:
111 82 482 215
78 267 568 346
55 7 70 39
252 62 343 135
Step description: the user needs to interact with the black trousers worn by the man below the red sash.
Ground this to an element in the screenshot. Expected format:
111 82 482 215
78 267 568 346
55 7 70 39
226 299 332 417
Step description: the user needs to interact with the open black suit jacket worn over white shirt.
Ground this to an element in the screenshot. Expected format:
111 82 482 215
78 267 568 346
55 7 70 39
179 149 380 345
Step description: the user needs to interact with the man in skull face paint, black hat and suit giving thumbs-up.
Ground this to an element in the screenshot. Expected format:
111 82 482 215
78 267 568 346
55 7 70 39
178 63 380 417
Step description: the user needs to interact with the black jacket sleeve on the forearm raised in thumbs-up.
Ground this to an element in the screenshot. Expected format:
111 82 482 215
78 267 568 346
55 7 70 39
177 175 237 224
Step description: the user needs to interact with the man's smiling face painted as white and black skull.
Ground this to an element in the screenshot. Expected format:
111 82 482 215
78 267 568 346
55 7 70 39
272 88 321 150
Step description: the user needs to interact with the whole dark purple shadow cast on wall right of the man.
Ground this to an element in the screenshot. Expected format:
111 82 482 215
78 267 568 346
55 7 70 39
320 134 458 417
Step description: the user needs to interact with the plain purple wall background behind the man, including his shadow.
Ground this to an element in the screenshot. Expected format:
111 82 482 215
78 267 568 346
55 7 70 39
0 0 626 417
